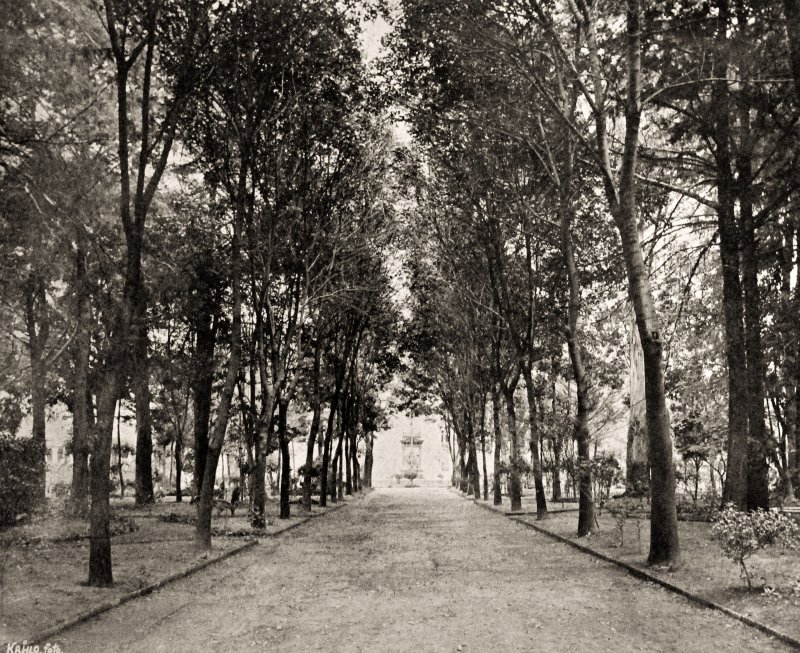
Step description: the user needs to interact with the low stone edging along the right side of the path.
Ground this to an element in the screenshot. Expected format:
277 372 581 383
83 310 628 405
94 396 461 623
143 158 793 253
456 492 800 650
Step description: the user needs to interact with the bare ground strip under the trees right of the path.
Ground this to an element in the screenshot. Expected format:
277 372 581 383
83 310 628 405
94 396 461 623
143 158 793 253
506 500 800 639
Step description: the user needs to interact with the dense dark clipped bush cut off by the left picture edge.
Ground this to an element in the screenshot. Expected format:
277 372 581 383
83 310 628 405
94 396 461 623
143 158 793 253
0 438 44 526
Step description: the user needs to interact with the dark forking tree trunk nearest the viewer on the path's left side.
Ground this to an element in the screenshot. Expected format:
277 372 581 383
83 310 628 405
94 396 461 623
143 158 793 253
88 0 208 585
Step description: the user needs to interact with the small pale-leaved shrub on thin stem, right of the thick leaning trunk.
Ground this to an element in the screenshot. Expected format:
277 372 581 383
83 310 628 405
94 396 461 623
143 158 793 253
711 505 800 589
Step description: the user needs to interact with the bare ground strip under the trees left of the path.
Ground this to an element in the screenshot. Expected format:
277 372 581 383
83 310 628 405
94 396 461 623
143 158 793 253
0 494 332 644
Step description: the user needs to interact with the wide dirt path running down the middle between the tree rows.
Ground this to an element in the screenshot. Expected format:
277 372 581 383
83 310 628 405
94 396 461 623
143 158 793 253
53 488 787 653
